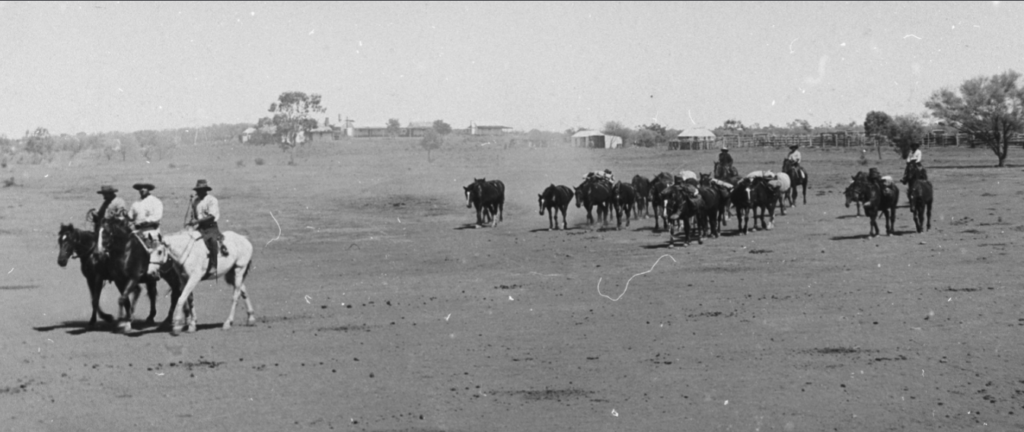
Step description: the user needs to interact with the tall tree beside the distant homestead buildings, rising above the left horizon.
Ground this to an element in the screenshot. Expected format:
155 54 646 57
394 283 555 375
261 91 327 164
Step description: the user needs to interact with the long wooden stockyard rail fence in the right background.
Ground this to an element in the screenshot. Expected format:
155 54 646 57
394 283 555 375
668 132 1024 150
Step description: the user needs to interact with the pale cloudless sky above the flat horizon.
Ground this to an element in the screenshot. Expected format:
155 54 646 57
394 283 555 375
0 2 1024 137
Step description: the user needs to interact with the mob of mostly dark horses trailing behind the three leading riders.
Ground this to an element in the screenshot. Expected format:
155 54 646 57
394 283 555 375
463 159 932 246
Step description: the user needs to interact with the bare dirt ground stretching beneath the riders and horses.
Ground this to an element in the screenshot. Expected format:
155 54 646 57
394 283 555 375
0 141 1024 431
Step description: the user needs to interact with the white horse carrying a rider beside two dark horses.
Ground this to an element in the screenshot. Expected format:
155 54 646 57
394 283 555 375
164 229 256 336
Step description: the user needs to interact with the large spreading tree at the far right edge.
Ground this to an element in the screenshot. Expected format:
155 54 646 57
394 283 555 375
925 70 1024 167
